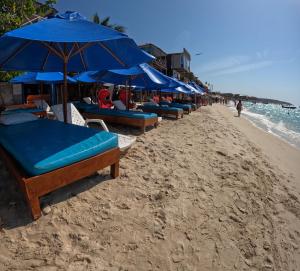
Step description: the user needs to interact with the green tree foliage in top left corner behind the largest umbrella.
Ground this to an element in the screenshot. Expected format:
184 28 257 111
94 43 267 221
0 0 56 81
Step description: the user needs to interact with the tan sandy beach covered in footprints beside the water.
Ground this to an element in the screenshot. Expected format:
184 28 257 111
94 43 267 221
0 105 300 271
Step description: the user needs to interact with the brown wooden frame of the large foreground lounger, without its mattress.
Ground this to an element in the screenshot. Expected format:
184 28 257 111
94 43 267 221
0 146 120 219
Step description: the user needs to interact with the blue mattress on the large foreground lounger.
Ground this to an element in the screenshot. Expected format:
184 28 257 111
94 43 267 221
0 119 118 176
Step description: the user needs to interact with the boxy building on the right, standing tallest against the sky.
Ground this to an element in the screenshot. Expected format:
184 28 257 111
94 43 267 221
167 48 191 82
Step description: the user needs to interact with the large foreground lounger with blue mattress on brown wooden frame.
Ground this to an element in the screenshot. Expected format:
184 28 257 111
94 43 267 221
0 115 120 219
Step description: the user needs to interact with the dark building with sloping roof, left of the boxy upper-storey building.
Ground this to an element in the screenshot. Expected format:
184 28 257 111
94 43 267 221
139 43 167 74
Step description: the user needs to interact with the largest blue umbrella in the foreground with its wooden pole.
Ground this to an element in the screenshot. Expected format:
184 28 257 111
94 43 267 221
0 12 151 122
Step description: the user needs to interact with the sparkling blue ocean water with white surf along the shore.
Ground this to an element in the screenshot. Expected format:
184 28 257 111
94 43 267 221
227 102 300 149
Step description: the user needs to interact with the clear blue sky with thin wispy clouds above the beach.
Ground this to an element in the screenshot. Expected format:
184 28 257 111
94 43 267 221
49 0 300 105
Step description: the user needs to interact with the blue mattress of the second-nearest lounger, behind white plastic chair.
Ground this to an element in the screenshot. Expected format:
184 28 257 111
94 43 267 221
75 103 157 119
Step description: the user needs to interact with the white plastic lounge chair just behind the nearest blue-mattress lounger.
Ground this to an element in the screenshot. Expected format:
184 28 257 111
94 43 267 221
51 103 136 152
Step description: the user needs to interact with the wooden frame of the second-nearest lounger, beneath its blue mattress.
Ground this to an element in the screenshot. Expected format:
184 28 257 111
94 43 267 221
80 111 158 133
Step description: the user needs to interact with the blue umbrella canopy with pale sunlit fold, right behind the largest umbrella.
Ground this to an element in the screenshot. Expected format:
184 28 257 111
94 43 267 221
75 63 179 90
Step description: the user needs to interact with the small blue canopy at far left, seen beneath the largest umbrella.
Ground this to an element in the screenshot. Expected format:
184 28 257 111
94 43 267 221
10 72 76 84
